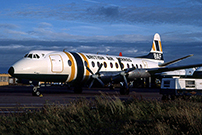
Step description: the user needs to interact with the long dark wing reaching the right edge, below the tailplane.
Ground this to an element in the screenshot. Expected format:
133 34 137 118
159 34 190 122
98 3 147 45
147 64 202 74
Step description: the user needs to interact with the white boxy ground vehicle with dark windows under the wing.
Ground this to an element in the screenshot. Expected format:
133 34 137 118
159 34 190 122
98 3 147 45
160 77 202 100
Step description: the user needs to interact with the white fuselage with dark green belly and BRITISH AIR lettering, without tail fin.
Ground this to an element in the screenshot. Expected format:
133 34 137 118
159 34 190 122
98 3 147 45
9 50 164 83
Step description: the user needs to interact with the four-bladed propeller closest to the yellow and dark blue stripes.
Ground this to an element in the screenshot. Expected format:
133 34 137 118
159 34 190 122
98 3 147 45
86 63 104 89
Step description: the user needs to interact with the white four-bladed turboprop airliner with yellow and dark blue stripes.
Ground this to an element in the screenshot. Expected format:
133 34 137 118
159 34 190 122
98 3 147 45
8 33 202 95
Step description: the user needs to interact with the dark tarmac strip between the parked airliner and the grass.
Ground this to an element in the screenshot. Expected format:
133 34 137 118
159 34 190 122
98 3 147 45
0 86 162 114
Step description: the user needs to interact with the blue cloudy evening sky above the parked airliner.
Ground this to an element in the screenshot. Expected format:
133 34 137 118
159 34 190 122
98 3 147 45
0 0 202 73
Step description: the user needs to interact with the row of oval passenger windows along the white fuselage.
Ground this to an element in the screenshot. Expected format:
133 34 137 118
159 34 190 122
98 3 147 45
68 60 143 69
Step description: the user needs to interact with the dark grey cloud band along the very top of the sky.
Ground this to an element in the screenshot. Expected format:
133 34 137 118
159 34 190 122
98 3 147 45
3 0 202 26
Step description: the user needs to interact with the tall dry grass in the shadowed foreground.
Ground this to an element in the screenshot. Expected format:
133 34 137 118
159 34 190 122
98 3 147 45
0 95 202 135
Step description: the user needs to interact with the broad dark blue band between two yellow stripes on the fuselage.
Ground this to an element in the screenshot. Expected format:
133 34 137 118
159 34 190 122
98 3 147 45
70 52 84 83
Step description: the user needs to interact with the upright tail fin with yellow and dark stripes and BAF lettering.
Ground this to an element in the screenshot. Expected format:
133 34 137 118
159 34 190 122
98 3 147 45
137 33 164 60
